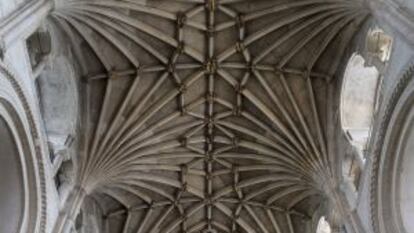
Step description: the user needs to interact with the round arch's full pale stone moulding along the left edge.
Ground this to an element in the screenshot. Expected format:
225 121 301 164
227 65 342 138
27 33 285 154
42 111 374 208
0 61 47 233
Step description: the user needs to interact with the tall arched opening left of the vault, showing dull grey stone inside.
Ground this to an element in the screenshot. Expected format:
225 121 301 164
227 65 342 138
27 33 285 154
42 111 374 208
31 25 80 194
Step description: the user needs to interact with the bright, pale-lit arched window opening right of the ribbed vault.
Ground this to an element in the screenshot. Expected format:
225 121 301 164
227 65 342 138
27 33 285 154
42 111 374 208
341 54 379 191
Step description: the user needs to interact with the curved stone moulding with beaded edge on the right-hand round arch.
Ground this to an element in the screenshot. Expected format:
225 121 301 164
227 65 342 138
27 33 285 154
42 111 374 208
370 65 414 233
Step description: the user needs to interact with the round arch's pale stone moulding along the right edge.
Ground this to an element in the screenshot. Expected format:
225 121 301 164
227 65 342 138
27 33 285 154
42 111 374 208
370 62 414 233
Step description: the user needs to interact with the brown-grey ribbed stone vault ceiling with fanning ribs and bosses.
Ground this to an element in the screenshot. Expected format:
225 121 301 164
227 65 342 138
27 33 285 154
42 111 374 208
49 0 365 233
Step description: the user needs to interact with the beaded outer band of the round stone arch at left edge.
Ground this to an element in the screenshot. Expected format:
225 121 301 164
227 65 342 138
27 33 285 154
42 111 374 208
0 62 47 233
